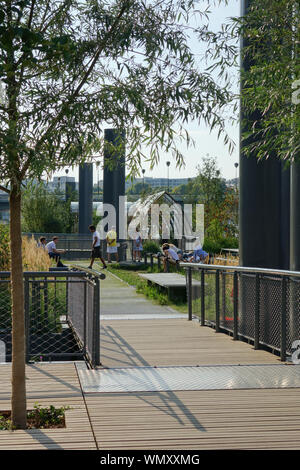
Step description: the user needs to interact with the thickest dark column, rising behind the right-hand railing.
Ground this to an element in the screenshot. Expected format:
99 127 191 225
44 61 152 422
239 0 289 269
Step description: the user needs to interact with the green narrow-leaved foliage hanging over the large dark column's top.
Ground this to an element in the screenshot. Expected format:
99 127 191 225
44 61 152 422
233 0 300 162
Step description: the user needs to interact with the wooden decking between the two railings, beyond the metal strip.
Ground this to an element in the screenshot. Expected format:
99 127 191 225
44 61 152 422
100 319 280 367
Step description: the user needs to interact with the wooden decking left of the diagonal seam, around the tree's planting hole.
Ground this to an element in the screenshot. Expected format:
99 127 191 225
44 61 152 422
0 363 96 450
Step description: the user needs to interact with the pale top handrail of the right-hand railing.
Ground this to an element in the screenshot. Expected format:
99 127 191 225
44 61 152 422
179 262 300 277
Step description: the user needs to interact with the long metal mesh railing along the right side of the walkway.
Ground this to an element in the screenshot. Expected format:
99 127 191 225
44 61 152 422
180 263 300 361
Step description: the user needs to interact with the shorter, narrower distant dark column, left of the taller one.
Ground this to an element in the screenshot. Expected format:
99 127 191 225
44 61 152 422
78 163 93 233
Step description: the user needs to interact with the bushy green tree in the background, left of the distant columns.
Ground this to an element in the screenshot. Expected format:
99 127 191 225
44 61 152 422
22 183 75 233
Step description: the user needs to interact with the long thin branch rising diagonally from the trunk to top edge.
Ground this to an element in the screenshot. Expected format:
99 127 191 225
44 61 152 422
21 0 131 178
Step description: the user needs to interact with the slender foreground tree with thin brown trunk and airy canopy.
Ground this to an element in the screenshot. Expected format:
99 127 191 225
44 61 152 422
0 0 236 428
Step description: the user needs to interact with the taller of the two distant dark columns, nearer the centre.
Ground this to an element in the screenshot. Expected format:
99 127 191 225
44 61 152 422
103 129 125 259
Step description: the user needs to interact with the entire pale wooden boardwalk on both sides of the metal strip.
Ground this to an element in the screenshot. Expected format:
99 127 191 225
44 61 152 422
0 274 300 451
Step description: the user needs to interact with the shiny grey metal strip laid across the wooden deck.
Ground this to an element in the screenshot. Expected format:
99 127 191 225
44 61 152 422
79 365 300 393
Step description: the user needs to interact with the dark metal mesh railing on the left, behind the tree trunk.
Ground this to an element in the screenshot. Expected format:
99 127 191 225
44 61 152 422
0 268 105 367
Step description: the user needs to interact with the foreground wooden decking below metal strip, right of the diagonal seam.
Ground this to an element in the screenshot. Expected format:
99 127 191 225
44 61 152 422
86 389 300 450
